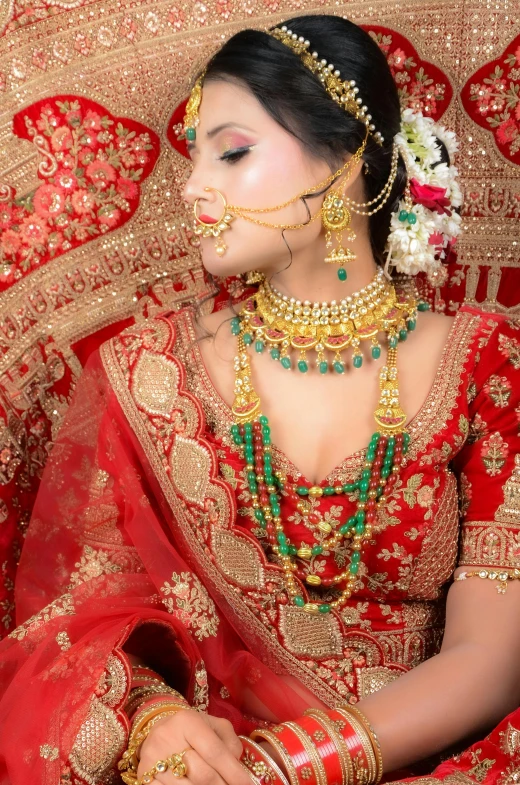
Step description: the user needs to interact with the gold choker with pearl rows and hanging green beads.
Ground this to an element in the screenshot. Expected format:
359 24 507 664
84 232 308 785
231 270 427 374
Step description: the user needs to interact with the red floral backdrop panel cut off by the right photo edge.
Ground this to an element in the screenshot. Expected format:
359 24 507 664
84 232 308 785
461 36 520 164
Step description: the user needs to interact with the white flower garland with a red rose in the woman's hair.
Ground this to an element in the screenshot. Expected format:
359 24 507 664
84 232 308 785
386 109 462 286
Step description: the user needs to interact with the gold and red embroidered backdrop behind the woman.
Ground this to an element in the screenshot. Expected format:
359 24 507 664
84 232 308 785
0 0 520 635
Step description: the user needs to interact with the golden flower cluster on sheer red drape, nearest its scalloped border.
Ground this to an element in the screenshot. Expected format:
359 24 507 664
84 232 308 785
161 572 220 641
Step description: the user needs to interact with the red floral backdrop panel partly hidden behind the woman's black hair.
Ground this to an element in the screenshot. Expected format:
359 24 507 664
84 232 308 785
362 25 453 120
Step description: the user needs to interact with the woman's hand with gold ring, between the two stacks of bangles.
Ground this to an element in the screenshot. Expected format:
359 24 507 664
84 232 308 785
137 709 251 785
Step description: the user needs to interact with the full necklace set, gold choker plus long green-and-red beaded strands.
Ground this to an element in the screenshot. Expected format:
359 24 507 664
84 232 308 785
231 273 428 613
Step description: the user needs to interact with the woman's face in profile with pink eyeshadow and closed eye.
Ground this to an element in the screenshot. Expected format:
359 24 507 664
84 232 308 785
184 81 330 276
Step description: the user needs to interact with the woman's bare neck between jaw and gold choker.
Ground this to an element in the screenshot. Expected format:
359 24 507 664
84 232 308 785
264 220 379 302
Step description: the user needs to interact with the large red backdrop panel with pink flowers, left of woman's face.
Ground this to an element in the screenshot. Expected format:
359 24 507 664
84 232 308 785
0 96 159 289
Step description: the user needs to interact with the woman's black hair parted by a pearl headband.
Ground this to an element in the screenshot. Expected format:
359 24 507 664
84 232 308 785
205 14 406 264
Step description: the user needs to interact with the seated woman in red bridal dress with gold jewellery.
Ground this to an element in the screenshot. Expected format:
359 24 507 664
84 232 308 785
0 16 520 785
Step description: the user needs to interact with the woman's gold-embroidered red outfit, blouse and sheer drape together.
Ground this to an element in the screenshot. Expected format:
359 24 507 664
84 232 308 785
0 308 520 785
